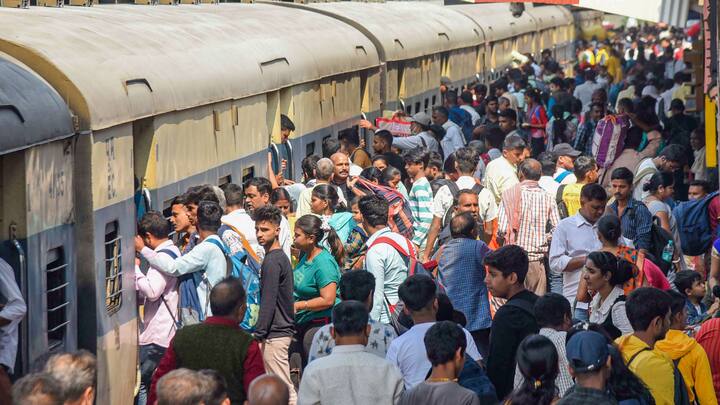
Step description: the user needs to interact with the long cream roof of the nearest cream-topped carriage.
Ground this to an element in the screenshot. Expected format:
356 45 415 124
0 3 380 130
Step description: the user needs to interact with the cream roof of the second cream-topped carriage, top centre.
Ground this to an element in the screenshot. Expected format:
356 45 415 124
308 1 485 61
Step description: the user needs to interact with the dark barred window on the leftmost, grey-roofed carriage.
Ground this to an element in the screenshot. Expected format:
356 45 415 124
45 247 70 353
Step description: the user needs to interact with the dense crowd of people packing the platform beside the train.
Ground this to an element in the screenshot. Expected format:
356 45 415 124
0 19 720 405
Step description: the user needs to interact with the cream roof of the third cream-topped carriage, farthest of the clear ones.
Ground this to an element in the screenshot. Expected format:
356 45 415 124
447 3 537 42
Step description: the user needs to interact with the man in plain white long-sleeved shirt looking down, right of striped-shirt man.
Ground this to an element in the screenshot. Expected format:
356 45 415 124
550 183 607 321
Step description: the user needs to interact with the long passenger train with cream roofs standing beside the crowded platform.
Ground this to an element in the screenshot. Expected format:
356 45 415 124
0 0 576 405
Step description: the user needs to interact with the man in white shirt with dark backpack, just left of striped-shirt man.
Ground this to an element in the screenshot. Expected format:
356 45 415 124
423 148 497 262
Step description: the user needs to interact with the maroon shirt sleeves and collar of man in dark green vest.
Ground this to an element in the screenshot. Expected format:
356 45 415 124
147 316 265 404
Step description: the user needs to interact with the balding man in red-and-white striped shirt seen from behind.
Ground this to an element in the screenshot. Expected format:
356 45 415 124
498 159 560 296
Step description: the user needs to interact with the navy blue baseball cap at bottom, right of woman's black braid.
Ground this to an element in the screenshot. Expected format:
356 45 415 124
565 331 610 373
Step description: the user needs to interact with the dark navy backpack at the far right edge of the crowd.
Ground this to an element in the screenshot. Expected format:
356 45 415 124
673 191 718 256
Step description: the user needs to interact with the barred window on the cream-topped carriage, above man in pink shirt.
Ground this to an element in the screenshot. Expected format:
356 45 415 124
105 221 122 315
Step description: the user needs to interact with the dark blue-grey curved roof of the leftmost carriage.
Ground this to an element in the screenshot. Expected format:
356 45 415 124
0 54 75 154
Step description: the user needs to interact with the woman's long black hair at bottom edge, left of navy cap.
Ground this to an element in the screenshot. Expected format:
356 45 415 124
508 335 560 405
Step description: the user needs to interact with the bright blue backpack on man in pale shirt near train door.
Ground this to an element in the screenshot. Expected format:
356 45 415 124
206 239 260 332
